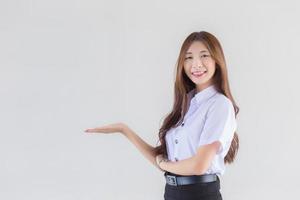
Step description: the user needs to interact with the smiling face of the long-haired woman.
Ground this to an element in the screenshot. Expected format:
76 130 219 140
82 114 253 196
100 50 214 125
183 41 216 92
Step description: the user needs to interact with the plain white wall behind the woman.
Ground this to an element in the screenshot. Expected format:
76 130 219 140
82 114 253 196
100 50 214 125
0 0 300 200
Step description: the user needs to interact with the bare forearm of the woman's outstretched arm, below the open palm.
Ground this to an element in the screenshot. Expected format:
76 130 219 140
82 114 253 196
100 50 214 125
122 127 159 168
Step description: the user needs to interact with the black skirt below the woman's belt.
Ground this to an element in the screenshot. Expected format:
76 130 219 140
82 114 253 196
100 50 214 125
164 173 222 200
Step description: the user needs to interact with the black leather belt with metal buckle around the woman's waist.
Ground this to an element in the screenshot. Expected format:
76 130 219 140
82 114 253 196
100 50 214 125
164 172 218 186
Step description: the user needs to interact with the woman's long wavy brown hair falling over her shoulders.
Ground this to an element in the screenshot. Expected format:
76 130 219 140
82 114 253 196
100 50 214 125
155 31 239 163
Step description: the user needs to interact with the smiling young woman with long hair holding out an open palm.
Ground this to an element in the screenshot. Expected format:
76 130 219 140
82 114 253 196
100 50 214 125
85 31 239 200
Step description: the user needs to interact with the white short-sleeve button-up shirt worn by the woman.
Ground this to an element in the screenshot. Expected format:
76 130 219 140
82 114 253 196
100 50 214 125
166 85 237 175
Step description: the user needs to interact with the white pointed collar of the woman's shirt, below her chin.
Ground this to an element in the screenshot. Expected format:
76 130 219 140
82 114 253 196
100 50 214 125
187 85 218 104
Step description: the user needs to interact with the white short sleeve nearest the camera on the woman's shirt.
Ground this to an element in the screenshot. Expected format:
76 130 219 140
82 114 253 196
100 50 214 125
198 98 237 156
